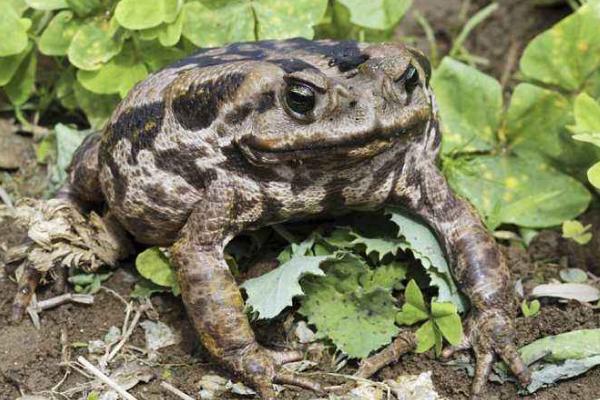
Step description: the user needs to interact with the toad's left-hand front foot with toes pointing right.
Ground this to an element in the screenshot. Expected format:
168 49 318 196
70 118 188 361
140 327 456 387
224 343 322 400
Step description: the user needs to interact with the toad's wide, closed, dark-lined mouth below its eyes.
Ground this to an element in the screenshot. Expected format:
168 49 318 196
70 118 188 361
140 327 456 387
238 124 421 164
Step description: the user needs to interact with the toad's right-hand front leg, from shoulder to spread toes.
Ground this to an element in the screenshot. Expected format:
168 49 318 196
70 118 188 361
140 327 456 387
394 159 529 396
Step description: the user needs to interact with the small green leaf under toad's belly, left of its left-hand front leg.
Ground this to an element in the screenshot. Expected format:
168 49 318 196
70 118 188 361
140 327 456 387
135 247 181 295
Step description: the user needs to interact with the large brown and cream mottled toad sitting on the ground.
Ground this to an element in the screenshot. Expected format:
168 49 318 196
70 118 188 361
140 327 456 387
17 39 528 399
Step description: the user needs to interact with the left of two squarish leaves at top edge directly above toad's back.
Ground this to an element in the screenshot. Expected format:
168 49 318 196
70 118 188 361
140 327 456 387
182 0 256 47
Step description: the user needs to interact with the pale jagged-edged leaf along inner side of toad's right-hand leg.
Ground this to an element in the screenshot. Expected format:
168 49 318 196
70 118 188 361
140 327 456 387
386 208 468 312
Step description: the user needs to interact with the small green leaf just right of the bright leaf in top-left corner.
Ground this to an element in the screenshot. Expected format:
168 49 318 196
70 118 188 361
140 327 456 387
38 11 80 56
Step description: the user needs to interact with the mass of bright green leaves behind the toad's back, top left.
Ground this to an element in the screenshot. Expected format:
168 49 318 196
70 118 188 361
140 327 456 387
0 0 411 128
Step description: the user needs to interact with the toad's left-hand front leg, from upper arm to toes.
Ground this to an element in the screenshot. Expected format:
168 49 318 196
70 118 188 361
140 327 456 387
172 201 320 400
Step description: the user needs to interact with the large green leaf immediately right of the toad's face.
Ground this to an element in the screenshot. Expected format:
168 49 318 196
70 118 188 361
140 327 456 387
431 57 503 154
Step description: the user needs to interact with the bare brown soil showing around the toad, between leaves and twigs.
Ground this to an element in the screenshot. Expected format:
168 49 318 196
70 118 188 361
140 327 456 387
0 0 600 400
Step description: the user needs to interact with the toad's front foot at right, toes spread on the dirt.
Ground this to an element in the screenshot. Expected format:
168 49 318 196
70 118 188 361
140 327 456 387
442 309 531 399
